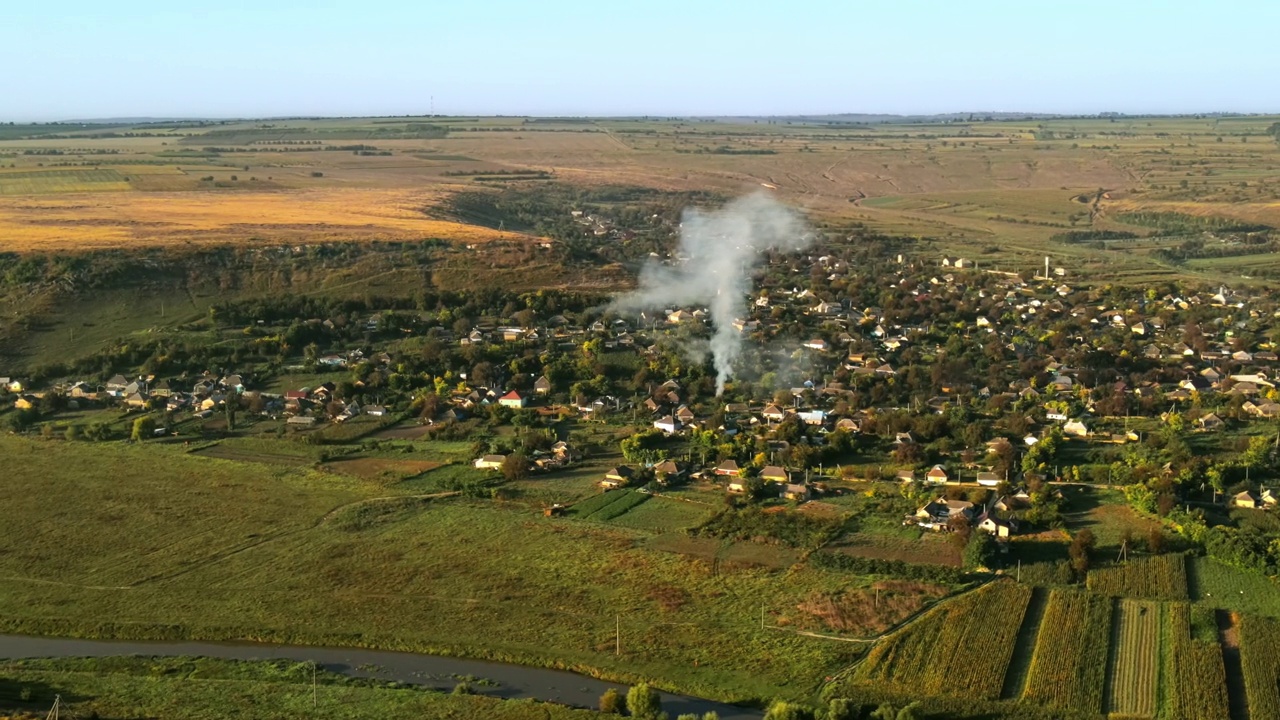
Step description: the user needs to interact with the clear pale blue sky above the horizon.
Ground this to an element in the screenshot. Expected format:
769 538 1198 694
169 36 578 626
0 0 1280 122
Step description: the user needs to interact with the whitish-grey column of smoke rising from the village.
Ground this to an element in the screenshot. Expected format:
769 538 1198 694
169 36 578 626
614 192 813 395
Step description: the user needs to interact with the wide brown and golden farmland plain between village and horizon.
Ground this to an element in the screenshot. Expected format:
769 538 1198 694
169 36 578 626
0 117 1280 283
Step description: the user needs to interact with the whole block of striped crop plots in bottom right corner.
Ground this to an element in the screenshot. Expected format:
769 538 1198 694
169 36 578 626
850 555 1280 720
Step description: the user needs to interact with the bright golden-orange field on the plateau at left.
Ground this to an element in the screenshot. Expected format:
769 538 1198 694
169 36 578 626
0 188 525 251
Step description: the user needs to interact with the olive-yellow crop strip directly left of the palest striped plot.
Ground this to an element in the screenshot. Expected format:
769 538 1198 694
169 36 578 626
1023 591 1111 712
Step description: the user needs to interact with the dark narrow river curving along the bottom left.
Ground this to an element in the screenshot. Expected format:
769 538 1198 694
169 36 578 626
0 635 764 720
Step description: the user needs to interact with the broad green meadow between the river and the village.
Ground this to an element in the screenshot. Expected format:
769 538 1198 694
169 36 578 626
0 430 859 700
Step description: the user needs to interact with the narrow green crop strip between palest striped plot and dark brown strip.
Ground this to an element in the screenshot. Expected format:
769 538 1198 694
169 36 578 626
1165 602 1231 720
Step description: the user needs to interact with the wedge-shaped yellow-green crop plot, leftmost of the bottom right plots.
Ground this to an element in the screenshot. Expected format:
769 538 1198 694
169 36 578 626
854 582 1032 700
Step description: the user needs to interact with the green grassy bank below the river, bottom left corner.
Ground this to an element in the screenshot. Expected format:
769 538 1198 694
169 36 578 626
0 657 598 720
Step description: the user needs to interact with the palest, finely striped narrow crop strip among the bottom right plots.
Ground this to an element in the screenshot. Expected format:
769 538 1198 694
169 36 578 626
1107 600 1162 717
